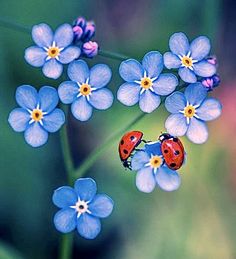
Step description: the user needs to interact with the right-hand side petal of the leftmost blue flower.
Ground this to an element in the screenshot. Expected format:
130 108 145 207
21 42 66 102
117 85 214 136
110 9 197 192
43 109 65 132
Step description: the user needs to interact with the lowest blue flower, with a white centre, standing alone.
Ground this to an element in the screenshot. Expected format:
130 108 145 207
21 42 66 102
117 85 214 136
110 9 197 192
52 178 114 239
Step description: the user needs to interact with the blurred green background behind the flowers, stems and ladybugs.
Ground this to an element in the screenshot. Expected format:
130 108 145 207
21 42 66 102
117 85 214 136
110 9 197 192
0 0 236 259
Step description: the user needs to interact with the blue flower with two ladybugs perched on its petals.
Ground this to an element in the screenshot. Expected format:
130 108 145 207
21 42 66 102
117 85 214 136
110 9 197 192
131 142 181 193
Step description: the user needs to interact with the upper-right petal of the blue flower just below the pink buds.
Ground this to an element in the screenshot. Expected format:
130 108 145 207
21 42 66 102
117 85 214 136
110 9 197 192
89 64 112 88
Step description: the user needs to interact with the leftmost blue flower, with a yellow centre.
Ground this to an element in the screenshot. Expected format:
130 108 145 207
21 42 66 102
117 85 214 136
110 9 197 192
8 85 65 147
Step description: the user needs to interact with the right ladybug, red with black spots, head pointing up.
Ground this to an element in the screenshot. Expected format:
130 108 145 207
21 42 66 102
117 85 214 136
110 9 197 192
159 133 185 170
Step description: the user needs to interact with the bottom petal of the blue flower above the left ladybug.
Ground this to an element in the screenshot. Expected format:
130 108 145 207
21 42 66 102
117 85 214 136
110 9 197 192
139 90 161 113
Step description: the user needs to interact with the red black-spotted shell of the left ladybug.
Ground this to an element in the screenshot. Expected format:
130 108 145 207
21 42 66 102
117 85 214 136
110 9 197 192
119 131 143 161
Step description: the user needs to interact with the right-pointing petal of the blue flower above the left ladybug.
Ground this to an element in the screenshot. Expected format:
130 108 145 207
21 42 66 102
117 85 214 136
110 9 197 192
152 74 179 95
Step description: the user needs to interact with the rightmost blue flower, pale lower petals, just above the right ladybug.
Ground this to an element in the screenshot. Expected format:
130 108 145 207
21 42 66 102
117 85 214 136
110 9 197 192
165 83 222 144
